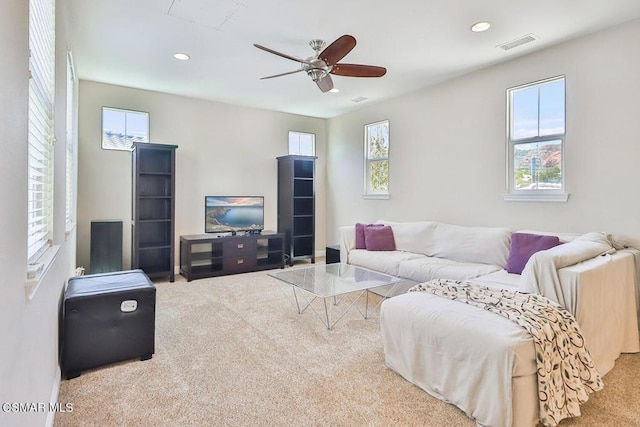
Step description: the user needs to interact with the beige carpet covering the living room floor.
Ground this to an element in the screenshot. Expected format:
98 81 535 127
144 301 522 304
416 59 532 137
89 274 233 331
55 272 640 426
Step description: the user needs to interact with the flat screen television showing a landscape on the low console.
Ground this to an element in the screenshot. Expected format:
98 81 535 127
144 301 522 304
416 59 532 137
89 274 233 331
204 196 264 234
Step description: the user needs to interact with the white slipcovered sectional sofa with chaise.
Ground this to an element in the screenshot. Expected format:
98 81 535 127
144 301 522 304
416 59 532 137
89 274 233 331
340 220 640 426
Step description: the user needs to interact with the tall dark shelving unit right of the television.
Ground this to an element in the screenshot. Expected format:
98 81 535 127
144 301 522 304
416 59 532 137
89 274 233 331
278 156 316 265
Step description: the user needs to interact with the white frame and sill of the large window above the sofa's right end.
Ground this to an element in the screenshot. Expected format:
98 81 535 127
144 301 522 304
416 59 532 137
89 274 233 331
503 75 570 202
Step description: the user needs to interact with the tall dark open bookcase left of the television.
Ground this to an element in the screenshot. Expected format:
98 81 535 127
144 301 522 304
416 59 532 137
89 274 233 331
131 143 178 282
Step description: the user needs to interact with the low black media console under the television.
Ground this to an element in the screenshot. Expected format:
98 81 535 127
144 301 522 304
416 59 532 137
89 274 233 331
180 233 284 281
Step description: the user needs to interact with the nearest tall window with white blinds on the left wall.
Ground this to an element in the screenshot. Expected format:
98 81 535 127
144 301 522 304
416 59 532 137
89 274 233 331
27 0 55 262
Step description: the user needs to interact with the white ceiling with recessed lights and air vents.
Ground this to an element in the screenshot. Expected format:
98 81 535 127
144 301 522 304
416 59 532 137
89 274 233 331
66 0 640 118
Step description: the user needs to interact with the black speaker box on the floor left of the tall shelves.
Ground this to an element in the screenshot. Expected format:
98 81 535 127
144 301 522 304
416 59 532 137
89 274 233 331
89 220 122 274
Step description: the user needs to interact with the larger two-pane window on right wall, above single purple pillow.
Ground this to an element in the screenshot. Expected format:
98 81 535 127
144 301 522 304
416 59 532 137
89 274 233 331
505 76 568 201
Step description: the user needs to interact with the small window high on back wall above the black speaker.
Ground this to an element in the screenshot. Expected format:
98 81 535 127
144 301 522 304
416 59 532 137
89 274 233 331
102 107 149 151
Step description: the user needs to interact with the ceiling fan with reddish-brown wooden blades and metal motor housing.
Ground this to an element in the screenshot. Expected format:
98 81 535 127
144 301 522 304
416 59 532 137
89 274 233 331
254 34 387 92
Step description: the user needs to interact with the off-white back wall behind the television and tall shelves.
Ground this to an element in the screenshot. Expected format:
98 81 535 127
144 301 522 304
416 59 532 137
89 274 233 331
77 81 326 269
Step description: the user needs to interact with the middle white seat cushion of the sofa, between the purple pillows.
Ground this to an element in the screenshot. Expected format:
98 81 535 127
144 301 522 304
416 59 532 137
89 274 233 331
398 257 502 282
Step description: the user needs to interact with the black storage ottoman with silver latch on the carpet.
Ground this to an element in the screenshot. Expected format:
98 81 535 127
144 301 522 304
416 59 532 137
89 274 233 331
61 270 156 378
